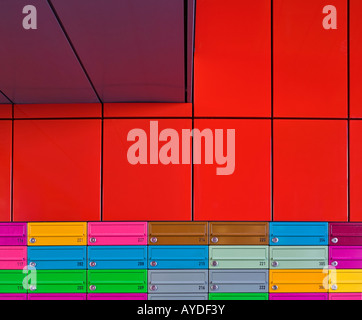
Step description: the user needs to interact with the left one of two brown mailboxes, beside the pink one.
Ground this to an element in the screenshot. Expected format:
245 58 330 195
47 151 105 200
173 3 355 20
148 222 208 245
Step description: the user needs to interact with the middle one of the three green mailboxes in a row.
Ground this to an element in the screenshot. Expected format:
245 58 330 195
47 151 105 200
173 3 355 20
29 270 87 293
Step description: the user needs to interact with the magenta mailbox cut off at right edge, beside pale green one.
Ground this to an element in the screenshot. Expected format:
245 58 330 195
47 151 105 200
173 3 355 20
329 246 362 269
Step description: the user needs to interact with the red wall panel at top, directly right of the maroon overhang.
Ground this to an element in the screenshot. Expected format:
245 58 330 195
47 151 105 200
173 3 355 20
195 0 271 117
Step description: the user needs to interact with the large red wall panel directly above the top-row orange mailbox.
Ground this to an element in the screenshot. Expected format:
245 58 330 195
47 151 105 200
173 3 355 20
14 120 101 221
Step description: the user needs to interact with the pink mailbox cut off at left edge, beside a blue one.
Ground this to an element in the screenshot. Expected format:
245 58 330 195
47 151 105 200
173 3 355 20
0 246 27 270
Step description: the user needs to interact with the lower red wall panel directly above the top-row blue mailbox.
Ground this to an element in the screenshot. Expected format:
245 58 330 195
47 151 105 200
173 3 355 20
274 120 347 221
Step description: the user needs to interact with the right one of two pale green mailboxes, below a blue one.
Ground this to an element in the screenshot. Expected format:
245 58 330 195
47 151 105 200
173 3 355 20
270 246 328 269
